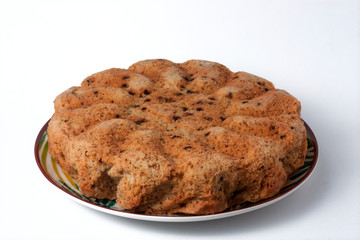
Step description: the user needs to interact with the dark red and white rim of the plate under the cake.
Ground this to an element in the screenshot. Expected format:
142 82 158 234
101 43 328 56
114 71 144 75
34 118 319 222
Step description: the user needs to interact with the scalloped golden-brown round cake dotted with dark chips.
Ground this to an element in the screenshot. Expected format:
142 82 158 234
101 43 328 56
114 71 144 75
48 59 307 215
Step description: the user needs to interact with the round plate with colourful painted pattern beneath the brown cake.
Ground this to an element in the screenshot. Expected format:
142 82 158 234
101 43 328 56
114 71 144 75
35 120 318 222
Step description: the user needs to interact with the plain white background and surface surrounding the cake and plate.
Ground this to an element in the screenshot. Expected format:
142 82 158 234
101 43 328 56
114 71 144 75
0 0 360 239
